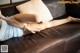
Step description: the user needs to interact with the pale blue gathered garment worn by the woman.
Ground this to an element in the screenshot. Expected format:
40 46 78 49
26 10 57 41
0 20 23 41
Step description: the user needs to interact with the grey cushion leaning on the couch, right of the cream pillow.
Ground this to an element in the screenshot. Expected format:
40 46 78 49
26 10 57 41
43 0 66 18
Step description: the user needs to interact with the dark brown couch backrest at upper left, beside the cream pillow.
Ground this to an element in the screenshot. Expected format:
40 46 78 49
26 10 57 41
0 2 24 16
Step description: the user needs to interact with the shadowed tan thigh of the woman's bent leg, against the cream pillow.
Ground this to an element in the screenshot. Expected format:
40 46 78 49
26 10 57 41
13 14 37 23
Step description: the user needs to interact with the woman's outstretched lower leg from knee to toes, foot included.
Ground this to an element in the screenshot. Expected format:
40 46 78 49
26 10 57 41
44 16 80 28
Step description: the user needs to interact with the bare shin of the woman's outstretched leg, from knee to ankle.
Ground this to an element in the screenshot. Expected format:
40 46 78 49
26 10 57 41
46 16 73 28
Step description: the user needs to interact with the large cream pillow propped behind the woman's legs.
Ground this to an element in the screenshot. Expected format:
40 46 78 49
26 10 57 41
16 0 53 22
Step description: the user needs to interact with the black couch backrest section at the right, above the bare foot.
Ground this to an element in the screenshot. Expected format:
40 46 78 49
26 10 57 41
66 4 80 18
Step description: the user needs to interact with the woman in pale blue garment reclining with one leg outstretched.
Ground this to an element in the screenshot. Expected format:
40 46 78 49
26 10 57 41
0 0 80 41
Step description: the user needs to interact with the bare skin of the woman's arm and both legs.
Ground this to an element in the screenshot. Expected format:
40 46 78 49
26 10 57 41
0 0 79 33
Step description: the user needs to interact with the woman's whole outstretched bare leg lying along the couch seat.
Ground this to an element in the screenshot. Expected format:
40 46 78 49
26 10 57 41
27 16 80 32
